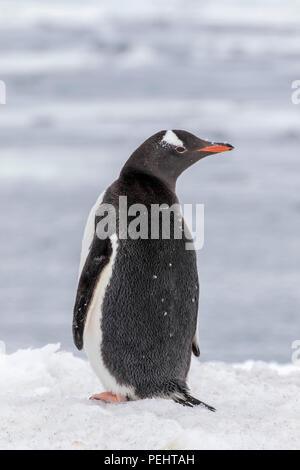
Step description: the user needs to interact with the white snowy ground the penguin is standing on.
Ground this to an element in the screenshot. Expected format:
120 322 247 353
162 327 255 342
0 344 300 450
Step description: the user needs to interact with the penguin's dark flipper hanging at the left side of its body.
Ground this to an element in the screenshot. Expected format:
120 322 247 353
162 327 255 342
72 232 112 350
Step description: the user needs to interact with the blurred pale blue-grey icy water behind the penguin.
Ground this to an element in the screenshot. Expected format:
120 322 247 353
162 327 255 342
0 0 300 362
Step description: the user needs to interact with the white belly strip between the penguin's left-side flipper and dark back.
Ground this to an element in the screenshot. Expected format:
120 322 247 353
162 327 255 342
83 230 135 398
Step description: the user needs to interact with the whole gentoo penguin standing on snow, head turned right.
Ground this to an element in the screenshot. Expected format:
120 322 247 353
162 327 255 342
73 130 233 411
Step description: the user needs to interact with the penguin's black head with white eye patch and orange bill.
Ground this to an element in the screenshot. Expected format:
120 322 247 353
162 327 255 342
124 130 234 187
